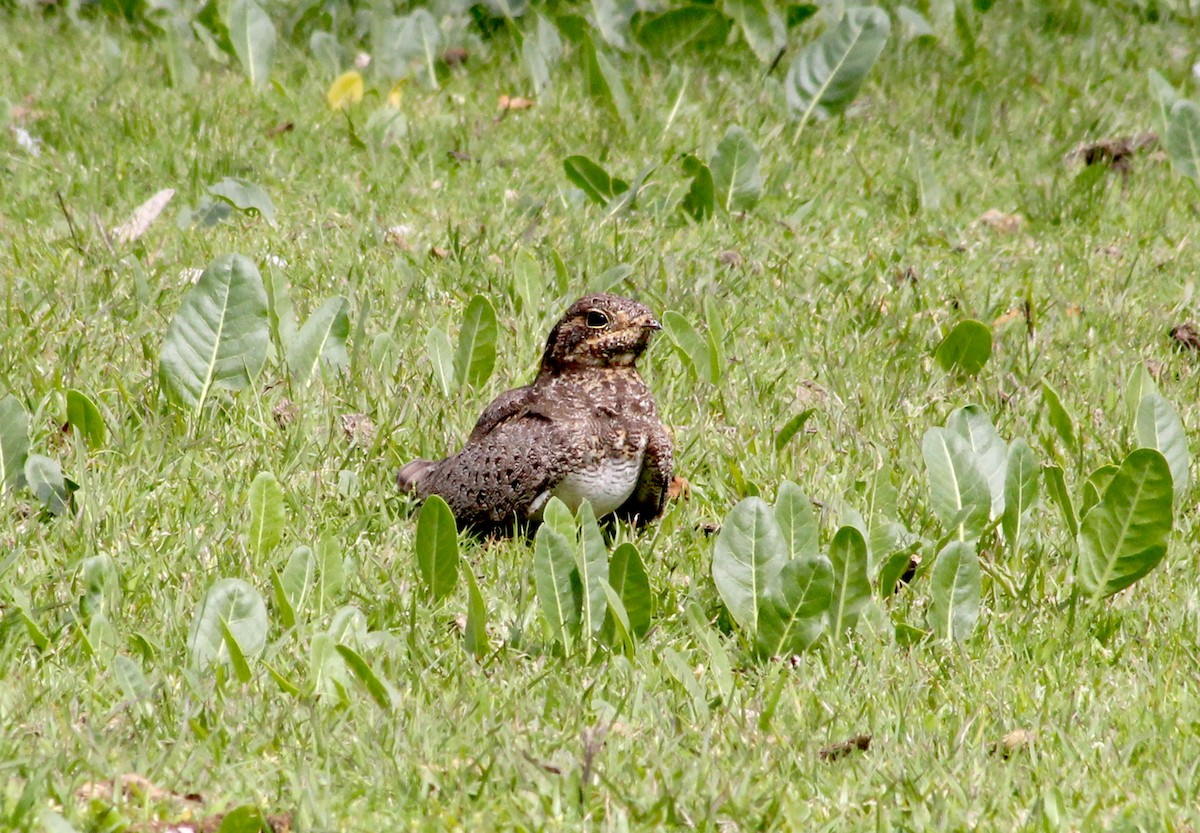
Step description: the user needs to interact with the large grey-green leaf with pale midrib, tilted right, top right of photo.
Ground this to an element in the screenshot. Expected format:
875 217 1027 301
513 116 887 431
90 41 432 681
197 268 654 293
785 6 892 127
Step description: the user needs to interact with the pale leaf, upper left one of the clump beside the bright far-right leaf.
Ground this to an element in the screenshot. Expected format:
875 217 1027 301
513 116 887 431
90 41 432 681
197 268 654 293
920 427 991 541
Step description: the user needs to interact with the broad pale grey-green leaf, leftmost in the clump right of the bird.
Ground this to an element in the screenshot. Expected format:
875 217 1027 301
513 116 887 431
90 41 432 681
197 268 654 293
713 497 787 637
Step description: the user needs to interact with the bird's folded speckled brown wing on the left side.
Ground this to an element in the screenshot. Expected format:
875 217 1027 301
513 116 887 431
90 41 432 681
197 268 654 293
420 410 577 529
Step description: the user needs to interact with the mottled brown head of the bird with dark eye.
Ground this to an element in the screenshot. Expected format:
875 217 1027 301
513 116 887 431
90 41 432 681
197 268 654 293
541 293 662 371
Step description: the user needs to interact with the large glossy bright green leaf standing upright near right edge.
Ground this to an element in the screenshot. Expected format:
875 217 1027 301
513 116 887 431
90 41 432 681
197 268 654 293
1075 449 1175 601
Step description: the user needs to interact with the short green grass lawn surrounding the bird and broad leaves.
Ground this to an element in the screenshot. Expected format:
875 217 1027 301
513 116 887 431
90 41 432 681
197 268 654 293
0 2 1200 831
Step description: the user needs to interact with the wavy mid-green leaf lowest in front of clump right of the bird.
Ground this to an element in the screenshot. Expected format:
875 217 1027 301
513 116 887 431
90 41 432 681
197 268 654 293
755 555 834 657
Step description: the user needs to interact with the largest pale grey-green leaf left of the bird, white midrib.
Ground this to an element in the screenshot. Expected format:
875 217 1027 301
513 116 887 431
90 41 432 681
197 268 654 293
158 254 269 413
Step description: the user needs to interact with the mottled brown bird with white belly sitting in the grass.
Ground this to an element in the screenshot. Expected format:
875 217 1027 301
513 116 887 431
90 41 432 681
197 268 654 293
396 293 674 537
